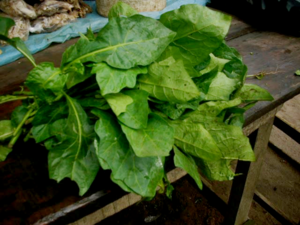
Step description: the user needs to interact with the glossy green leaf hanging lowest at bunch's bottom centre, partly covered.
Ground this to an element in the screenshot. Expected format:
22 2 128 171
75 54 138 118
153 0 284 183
93 110 164 197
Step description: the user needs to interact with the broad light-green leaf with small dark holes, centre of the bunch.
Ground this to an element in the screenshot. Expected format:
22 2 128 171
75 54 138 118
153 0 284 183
138 59 200 103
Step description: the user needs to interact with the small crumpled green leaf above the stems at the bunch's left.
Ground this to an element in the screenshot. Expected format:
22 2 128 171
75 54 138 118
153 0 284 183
25 63 68 103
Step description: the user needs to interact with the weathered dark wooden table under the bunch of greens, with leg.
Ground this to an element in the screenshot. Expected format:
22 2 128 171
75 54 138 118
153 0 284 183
0 10 300 225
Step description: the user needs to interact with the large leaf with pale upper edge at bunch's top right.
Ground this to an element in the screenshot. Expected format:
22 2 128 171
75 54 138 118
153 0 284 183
160 4 231 66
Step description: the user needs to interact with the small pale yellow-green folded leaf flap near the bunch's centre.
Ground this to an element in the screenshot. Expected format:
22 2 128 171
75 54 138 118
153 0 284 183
105 93 133 116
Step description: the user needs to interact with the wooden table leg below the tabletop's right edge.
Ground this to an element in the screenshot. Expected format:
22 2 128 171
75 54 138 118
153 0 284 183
225 117 274 225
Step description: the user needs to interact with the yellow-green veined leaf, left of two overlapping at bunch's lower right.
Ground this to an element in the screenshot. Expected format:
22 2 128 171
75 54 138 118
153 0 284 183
174 122 222 160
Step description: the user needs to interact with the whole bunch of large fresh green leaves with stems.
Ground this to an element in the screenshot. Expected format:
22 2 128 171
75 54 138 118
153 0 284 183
0 2 272 198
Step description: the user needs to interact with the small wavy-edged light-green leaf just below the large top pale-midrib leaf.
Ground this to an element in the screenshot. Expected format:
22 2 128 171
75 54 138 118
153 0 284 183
92 63 148 96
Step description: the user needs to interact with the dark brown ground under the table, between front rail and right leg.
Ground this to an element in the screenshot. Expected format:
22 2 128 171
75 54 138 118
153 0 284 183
98 176 224 225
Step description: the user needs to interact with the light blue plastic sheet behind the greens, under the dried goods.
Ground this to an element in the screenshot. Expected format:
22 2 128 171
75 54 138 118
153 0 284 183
0 0 209 66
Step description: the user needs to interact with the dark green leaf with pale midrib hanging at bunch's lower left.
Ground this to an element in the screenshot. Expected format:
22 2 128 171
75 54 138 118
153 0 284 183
48 95 99 195
